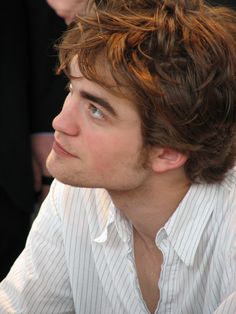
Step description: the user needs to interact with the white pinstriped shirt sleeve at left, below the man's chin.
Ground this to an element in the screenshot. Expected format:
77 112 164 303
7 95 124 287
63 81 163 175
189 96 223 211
0 182 74 314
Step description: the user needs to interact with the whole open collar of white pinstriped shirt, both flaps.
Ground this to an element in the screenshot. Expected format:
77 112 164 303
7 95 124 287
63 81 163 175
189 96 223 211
94 171 232 266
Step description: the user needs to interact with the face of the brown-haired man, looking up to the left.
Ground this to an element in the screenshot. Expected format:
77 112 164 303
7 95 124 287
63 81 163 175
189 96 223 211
47 58 152 191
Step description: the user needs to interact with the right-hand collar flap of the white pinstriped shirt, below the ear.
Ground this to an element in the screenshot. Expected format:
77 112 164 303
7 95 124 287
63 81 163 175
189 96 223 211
160 184 217 266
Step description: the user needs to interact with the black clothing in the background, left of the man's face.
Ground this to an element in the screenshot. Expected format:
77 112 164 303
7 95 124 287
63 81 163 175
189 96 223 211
0 0 66 280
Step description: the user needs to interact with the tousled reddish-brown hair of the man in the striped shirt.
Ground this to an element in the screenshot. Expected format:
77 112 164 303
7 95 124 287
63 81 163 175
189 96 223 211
59 0 236 183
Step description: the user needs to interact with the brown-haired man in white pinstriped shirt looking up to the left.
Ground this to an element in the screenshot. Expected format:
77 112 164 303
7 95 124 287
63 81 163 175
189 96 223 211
0 0 236 314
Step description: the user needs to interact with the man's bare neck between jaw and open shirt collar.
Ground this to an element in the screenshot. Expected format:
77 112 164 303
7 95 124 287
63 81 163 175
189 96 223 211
109 169 190 244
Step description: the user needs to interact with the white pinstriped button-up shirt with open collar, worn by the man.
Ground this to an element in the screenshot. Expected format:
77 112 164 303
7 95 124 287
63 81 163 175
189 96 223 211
0 171 236 314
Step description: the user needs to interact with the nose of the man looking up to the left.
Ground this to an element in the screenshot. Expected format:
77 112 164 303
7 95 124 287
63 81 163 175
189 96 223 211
52 94 79 136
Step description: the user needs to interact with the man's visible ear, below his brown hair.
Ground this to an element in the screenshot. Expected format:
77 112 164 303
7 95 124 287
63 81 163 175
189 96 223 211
150 148 188 173
